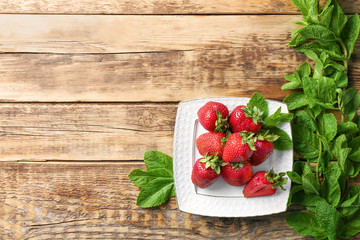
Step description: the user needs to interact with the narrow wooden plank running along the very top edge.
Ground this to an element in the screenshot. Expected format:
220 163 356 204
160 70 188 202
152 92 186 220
0 0 360 14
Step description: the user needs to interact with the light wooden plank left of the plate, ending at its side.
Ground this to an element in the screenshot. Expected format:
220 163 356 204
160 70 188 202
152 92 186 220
0 103 177 161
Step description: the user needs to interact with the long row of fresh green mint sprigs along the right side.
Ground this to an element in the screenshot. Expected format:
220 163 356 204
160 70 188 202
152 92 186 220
280 0 360 240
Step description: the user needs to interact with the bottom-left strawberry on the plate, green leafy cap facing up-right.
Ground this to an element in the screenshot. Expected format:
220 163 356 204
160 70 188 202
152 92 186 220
191 155 222 188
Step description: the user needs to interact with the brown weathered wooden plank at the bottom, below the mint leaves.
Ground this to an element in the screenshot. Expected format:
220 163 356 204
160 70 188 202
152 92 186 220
0 163 358 240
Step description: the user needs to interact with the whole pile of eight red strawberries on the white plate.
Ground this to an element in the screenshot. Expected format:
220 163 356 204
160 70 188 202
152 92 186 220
191 102 286 198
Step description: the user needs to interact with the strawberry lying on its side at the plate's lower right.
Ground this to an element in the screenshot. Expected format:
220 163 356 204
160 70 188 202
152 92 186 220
243 169 287 198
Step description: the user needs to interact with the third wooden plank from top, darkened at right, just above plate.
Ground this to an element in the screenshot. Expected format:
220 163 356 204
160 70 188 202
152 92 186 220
0 50 360 102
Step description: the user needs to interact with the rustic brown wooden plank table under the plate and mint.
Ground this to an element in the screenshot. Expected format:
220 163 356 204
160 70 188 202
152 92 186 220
0 0 360 239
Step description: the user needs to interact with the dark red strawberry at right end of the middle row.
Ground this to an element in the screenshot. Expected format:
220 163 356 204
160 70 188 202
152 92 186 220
250 133 279 166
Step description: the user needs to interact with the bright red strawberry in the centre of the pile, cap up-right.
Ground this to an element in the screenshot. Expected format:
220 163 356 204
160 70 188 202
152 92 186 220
222 132 255 162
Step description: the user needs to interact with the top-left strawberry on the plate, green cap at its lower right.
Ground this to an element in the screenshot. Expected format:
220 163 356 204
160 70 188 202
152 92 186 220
197 102 229 132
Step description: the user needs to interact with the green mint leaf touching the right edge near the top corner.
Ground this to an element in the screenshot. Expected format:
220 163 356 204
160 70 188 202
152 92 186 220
341 14 360 59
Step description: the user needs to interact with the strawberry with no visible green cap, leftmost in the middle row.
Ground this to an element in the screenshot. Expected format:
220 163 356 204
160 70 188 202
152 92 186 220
196 132 225 158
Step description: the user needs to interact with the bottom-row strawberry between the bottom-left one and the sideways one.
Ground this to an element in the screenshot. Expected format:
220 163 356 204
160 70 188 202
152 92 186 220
220 161 253 186
